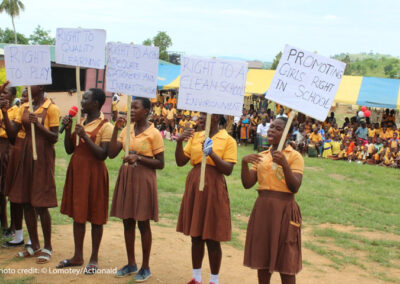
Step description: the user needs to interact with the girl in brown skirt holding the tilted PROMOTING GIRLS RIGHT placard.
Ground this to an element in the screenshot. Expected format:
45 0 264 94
242 117 304 284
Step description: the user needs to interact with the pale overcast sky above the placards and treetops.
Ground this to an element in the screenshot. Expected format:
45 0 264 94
0 0 400 61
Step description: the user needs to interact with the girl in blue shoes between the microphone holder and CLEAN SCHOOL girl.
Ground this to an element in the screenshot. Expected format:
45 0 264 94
109 97 164 282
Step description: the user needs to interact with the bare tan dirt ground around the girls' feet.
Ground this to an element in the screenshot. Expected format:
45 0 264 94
0 220 394 284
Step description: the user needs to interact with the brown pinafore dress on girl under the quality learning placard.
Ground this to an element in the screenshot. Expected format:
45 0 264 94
60 119 109 225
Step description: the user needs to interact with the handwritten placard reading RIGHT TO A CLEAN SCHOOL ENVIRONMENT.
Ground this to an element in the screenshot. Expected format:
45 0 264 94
178 56 247 116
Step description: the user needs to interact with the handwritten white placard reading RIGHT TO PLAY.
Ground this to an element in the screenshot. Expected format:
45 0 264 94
4 45 52 86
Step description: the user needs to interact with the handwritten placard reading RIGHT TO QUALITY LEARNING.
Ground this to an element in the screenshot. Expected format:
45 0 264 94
56 28 106 69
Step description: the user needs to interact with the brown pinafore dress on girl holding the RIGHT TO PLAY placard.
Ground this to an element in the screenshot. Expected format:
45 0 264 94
6 104 57 208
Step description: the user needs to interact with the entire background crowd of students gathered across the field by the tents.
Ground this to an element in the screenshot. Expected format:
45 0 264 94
141 93 400 168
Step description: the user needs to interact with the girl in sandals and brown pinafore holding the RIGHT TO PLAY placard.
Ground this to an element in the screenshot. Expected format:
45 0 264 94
2 86 60 264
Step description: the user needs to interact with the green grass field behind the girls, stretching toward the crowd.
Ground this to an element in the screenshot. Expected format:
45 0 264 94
4 137 400 282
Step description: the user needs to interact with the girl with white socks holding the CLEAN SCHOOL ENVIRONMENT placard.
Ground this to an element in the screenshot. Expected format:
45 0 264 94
175 113 237 284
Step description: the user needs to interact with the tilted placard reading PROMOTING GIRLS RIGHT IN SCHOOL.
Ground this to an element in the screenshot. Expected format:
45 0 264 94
265 45 346 121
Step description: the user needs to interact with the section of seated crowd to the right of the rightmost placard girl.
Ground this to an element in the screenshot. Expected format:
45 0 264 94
291 110 400 168
